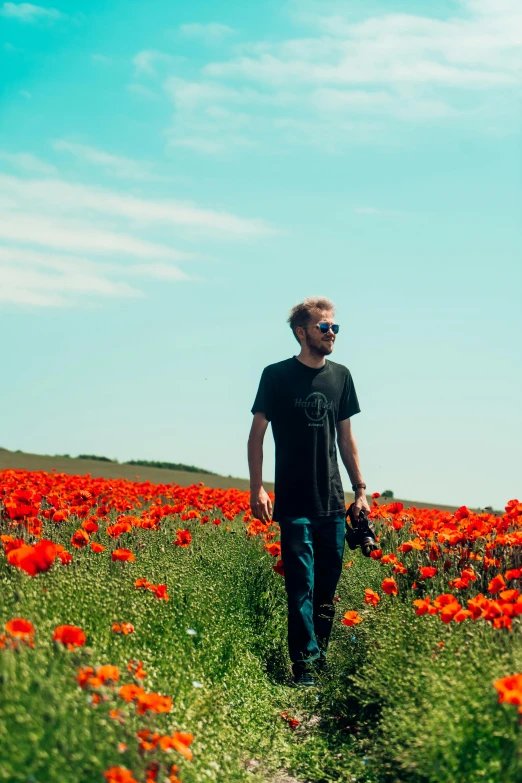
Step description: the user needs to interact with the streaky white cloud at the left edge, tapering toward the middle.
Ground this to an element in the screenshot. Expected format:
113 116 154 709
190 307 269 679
0 167 271 307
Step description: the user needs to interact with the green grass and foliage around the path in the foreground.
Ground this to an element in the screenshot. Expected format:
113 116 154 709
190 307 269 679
0 508 522 783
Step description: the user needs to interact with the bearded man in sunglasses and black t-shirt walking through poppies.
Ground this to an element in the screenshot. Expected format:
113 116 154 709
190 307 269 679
248 297 370 686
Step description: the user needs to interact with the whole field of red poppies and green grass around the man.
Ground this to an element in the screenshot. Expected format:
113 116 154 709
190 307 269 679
0 470 522 783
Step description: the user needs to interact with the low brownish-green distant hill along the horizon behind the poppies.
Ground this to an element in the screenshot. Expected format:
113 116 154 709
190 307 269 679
0 448 476 514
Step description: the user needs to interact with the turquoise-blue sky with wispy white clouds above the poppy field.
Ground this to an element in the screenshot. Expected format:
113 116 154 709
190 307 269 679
0 0 522 508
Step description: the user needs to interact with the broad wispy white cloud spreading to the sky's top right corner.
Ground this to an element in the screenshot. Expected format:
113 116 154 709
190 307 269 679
155 0 522 154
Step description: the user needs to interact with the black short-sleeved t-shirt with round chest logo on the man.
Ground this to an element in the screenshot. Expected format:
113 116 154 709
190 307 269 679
252 356 360 521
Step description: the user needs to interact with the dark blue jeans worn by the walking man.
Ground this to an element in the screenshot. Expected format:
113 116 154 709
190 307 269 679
279 514 345 674
